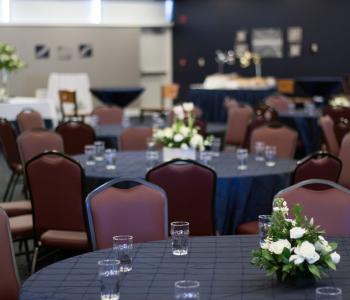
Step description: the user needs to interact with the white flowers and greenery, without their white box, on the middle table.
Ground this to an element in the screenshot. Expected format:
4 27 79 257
153 102 211 150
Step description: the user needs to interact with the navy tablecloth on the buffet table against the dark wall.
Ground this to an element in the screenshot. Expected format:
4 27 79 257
186 89 276 122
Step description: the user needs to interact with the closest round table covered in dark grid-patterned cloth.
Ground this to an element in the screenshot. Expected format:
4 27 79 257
19 236 350 300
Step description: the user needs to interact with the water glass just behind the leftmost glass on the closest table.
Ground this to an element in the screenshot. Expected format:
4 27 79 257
113 235 133 272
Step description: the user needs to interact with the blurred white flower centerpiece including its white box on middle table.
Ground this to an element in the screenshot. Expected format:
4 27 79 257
153 102 210 161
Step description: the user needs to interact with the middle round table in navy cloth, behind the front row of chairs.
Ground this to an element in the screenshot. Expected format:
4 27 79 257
74 151 296 234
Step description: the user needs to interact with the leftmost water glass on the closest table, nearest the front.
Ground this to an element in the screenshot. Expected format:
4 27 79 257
98 259 120 300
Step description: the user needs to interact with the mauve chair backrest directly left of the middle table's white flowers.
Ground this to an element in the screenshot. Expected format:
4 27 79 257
118 127 153 151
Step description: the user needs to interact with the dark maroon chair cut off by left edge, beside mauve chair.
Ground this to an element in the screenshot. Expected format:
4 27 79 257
0 118 23 201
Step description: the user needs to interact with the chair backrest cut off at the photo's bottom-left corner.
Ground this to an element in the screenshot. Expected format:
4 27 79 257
0 208 20 300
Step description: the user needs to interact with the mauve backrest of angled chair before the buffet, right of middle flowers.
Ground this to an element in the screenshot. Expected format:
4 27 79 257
225 106 253 146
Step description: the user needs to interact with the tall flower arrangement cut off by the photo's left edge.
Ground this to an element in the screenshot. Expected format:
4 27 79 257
0 42 25 99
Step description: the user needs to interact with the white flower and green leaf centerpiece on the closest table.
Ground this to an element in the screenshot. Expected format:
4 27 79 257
252 198 340 286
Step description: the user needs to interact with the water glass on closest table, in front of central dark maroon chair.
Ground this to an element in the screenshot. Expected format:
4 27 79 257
170 222 190 256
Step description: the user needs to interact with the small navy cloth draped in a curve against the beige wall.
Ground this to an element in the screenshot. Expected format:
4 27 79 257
90 87 144 107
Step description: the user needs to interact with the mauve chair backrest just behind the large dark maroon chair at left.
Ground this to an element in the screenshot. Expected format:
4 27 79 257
17 130 64 164
